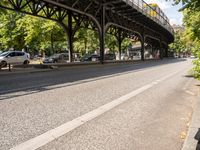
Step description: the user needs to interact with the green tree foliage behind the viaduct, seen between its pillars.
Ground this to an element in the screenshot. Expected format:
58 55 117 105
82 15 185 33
0 9 132 55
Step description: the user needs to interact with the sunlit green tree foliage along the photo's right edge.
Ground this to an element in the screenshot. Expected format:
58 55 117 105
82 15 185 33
172 0 200 79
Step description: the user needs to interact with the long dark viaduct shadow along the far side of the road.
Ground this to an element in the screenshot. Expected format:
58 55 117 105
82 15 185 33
0 59 186 100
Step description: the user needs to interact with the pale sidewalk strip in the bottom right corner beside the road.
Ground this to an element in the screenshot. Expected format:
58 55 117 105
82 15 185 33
182 97 200 150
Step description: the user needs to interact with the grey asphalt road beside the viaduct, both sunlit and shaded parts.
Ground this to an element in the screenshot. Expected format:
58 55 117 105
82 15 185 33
0 59 198 150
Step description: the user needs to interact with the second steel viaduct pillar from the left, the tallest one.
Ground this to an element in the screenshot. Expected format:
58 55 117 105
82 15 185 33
99 4 105 64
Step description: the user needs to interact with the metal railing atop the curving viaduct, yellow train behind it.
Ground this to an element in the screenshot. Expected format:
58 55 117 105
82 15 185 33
124 0 174 34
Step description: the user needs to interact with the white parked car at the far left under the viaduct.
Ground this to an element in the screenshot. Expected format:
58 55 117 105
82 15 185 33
0 51 30 67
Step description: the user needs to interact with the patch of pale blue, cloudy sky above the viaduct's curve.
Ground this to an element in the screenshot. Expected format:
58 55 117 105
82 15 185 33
144 0 183 25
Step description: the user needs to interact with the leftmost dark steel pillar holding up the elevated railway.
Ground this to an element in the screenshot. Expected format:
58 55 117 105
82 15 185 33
68 11 73 62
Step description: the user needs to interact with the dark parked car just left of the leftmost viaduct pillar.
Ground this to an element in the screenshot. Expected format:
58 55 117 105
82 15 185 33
43 53 69 63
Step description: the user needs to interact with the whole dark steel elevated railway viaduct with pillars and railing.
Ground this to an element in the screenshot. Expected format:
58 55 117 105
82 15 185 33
0 0 174 63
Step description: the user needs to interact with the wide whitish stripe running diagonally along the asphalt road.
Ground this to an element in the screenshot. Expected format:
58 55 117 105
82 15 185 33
10 70 181 150
